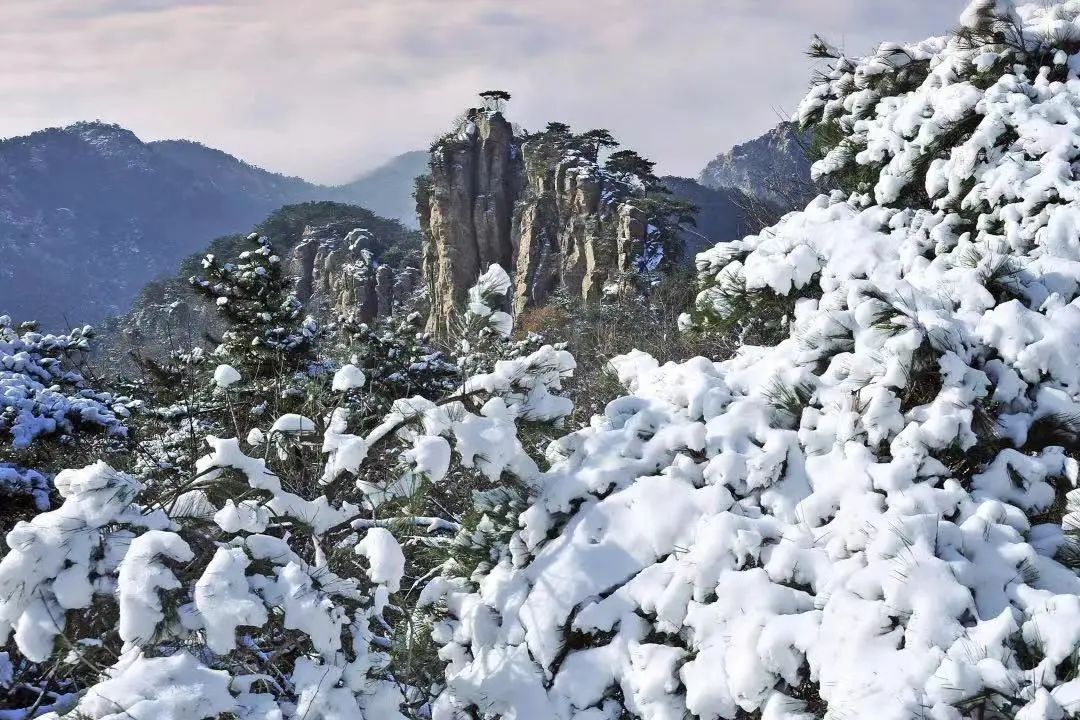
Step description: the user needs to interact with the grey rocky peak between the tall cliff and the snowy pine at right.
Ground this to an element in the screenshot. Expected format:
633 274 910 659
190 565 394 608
699 122 812 209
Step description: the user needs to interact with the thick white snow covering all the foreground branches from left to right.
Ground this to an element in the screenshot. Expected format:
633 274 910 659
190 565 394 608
16 0 1080 720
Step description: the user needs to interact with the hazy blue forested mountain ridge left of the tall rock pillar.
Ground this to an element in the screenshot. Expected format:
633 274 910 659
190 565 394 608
0 122 424 328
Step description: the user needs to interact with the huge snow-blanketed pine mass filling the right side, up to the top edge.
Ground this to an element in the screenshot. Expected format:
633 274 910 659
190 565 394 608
423 0 1080 720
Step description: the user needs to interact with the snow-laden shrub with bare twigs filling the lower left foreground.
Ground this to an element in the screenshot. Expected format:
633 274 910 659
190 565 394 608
0 270 573 720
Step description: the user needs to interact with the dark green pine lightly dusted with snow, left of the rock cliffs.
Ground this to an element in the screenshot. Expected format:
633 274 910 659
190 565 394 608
131 234 334 511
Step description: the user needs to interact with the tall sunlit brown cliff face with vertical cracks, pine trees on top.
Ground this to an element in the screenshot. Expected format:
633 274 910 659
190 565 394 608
416 109 646 334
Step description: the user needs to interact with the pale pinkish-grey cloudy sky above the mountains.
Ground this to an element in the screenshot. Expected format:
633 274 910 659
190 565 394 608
0 0 966 182
